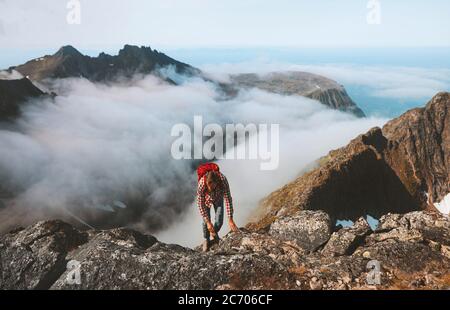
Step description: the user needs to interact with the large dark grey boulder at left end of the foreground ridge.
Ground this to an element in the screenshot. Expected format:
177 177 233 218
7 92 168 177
0 221 87 289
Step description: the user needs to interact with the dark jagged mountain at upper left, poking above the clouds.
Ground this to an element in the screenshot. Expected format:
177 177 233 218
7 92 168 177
9 45 199 82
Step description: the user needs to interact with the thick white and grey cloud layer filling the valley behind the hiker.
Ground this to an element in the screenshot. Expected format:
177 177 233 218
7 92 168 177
0 69 385 245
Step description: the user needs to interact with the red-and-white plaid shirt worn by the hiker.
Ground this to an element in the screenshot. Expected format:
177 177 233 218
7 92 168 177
197 172 233 219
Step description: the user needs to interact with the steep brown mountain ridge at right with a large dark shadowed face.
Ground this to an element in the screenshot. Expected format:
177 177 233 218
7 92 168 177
249 93 450 229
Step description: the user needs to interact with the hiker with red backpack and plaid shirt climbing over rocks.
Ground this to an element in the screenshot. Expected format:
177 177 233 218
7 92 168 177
197 163 239 252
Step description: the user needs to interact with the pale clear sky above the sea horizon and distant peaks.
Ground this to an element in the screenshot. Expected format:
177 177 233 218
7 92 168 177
0 0 450 49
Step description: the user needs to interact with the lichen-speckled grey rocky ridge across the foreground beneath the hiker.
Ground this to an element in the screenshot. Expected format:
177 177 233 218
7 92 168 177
0 211 450 290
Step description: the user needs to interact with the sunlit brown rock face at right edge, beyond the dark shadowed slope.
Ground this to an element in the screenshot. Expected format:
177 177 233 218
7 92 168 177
383 93 450 206
